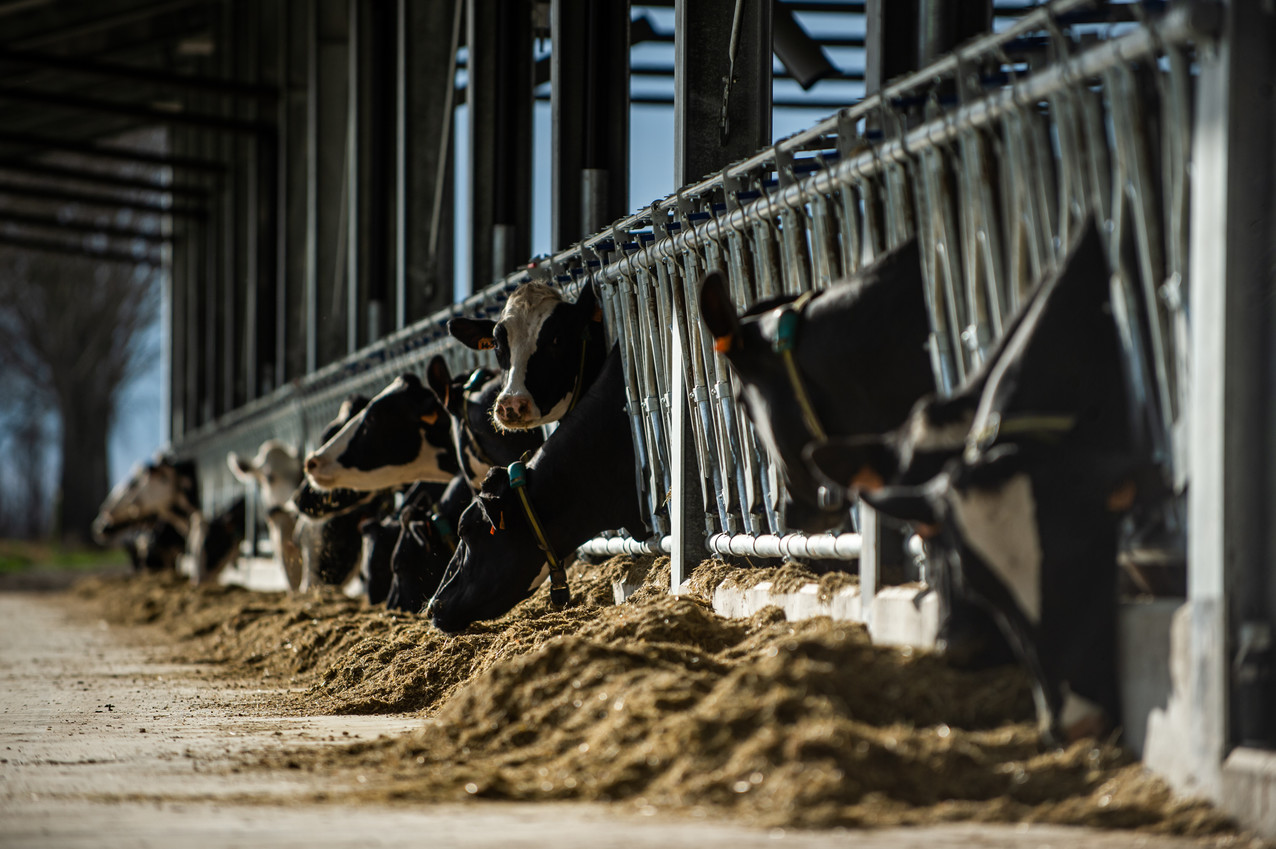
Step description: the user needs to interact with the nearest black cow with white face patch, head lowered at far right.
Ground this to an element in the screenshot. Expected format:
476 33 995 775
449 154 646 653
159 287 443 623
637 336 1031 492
809 219 1148 740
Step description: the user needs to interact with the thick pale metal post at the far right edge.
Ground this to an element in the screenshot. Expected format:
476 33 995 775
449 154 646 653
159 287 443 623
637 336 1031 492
1146 1 1276 803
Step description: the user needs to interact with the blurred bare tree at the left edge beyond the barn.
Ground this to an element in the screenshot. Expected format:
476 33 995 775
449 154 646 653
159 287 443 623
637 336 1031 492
0 253 161 543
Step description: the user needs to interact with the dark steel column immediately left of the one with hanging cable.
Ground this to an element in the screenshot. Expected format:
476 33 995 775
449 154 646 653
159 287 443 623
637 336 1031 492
550 0 629 250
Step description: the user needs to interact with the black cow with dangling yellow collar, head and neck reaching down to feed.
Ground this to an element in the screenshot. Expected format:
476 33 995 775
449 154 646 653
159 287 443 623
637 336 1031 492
430 349 644 632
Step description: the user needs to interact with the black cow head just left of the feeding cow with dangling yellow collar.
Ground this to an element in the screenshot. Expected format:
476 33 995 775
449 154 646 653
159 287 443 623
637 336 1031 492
385 475 473 613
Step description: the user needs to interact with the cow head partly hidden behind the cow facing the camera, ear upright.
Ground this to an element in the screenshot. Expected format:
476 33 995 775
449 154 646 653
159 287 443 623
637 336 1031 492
425 356 545 482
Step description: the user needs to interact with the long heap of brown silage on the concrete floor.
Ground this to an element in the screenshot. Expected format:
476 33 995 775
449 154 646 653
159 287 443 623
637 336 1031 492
69 558 1229 835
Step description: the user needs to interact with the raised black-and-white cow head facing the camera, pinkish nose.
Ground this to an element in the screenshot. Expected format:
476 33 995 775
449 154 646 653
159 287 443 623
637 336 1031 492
448 282 606 430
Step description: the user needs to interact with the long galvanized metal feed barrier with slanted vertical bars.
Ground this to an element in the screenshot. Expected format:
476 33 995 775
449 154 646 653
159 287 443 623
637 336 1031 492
176 0 1217 594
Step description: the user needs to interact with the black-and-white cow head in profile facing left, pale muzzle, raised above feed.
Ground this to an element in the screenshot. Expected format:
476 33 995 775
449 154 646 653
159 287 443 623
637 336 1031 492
306 374 457 492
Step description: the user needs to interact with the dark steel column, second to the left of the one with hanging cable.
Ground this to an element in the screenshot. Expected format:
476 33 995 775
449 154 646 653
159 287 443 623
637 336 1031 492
466 0 532 291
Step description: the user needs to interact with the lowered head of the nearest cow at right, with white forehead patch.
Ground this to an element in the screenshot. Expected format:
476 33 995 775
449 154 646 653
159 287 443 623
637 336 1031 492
864 444 1139 742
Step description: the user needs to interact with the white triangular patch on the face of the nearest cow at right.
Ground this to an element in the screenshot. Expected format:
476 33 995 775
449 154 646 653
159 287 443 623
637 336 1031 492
949 475 1041 624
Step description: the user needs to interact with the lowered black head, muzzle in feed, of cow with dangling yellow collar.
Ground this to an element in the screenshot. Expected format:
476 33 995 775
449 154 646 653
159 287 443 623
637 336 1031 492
429 466 553 633
